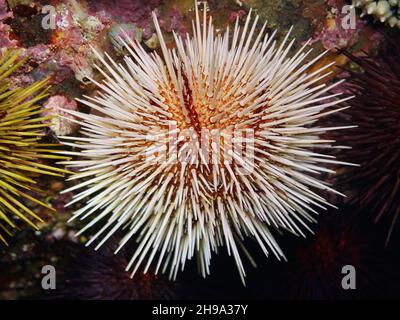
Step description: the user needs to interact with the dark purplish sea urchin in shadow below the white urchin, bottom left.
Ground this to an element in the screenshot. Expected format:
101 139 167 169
52 241 180 300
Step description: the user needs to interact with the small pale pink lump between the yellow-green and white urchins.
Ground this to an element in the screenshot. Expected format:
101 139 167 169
43 95 78 136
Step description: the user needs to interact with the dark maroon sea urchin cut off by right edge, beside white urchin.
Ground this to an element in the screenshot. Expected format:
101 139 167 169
338 41 400 245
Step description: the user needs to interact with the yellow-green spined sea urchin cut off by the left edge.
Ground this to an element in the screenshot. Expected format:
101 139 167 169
0 50 70 244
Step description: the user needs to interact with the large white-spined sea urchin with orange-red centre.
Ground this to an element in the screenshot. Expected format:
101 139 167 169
63 1 349 279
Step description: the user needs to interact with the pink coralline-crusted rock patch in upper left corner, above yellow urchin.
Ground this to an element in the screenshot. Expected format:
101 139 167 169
0 0 107 85
